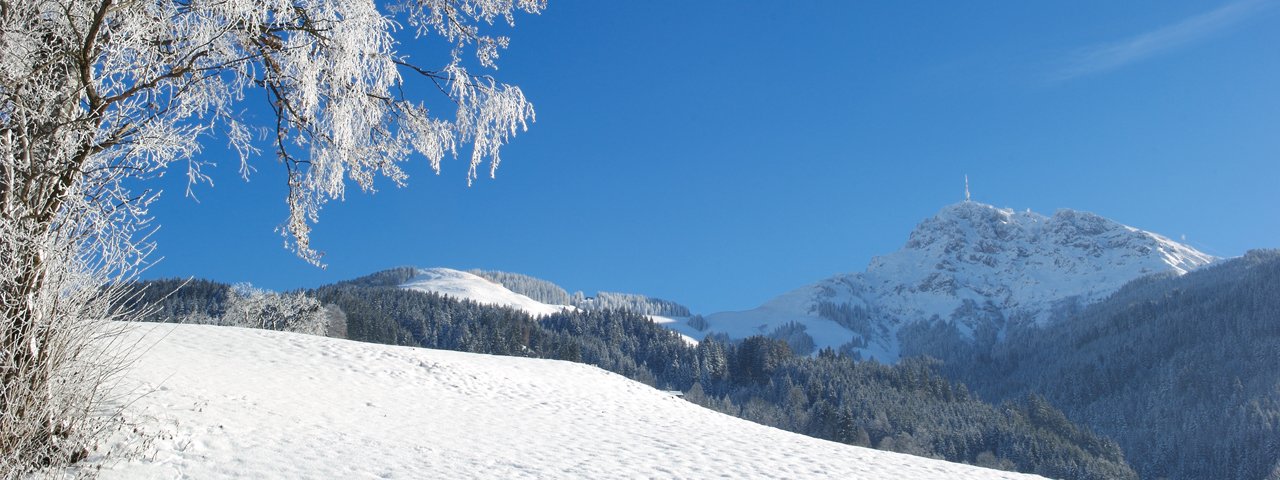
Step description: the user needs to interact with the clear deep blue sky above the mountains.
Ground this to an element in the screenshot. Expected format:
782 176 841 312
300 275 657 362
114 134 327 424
145 0 1280 312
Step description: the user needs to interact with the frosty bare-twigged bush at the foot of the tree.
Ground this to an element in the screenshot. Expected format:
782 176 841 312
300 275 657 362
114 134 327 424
0 212 142 479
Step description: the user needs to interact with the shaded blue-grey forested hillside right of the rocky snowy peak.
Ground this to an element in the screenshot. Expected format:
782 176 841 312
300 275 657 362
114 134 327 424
942 250 1280 479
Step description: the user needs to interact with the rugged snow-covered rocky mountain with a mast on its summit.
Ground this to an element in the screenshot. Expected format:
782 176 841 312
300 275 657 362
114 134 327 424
708 201 1217 361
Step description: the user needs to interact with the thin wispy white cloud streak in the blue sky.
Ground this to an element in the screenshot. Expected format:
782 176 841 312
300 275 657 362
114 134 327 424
1051 0 1275 82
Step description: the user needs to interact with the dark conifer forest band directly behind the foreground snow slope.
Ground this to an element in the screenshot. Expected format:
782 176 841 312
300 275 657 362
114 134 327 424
122 269 1135 479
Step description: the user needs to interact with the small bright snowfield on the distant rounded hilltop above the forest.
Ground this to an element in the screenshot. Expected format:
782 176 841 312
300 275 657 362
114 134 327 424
401 268 572 316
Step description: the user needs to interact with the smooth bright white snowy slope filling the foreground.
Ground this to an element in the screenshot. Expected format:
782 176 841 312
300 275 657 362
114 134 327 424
88 324 1033 479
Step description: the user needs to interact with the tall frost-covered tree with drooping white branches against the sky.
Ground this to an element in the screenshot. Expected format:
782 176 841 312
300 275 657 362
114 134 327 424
0 0 545 473
